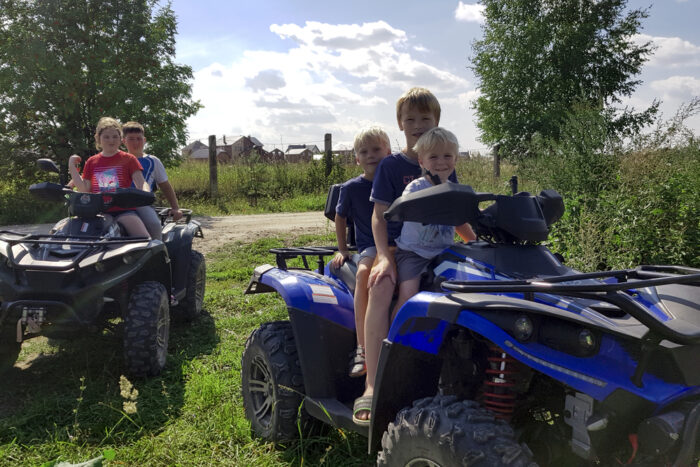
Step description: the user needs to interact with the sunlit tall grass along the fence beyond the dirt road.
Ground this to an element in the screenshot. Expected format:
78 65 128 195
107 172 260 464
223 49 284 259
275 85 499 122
0 158 515 225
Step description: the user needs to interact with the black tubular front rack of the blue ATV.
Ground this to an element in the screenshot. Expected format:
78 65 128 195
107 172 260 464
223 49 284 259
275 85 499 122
441 265 700 387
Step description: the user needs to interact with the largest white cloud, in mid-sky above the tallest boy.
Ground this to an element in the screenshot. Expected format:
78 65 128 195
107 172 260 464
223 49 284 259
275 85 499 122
183 21 474 150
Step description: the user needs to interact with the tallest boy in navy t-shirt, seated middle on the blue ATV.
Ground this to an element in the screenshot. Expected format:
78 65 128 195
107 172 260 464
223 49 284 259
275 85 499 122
353 88 457 425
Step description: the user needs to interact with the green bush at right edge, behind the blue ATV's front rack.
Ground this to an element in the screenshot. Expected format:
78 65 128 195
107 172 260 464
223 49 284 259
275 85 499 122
519 103 700 270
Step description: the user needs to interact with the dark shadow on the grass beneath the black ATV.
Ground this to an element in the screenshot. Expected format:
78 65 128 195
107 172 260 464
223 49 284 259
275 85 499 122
0 313 218 445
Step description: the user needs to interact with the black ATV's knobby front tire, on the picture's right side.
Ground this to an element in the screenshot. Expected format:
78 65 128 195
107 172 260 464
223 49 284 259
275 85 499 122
124 282 170 377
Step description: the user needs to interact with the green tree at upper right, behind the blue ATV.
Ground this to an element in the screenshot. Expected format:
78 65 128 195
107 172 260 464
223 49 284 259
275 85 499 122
473 0 658 156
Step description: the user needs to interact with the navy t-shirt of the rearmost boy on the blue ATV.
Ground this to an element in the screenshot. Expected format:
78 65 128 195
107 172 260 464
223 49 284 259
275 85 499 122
335 175 374 253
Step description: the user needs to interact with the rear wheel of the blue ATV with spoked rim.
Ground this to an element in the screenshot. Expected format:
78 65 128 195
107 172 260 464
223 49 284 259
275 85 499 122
241 321 305 443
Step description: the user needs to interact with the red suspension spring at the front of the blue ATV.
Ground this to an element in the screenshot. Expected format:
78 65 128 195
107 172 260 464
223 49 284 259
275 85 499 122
481 346 520 421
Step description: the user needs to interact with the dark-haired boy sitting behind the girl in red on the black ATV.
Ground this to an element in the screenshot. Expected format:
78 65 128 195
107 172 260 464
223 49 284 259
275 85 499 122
122 122 182 240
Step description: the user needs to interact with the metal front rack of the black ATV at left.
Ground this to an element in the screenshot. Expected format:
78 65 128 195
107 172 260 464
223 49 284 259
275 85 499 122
0 230 150 271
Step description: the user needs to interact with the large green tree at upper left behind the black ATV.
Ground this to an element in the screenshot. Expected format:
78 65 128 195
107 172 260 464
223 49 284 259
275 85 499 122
0 0 200 179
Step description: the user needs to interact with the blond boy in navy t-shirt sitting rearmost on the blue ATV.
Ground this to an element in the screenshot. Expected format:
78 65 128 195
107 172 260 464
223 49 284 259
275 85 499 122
332 127 391 377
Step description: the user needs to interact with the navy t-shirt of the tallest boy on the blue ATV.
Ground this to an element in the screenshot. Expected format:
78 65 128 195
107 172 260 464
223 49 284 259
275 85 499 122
370 152 457 245
